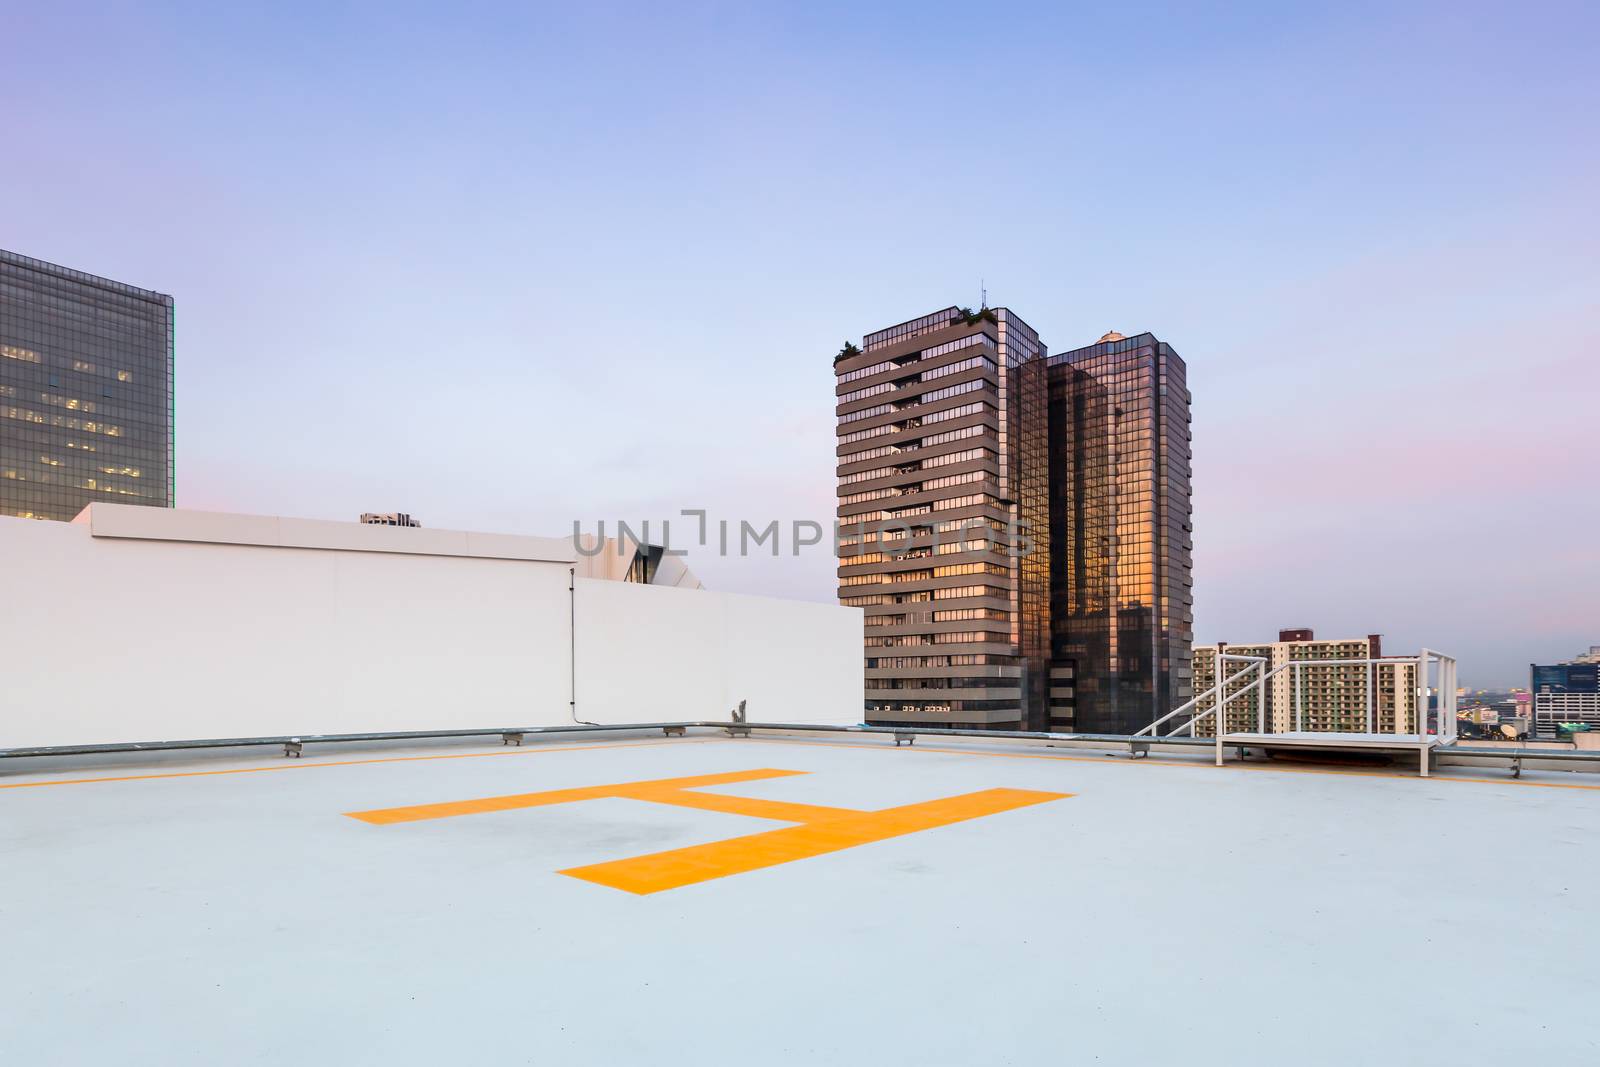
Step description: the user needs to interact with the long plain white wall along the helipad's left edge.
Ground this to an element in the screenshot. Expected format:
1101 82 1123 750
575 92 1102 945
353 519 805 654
0 504 862 750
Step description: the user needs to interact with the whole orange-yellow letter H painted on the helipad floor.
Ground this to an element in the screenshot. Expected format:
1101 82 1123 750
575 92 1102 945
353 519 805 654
347 768 1072 894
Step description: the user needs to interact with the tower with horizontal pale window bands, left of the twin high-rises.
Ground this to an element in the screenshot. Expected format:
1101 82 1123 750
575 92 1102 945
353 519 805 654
834 307 1048 728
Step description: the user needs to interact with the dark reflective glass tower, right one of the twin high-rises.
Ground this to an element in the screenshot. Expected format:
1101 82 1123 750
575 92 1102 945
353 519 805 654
1050 333 1194 734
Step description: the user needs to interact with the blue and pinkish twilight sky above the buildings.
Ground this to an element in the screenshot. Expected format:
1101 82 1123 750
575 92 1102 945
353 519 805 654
0 2 1600 686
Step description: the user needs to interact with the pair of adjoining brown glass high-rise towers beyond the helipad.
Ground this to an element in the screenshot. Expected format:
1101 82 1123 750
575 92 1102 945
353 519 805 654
834 307 1192 733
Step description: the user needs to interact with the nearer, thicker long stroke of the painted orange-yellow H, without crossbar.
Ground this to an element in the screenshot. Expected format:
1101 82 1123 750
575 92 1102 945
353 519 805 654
560 789 1072 896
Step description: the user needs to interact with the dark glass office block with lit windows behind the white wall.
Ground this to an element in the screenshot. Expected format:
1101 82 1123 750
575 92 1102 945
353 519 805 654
0 250 173 520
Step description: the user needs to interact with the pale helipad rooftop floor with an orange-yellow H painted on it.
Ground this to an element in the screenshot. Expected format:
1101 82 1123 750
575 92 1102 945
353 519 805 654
0 731 1600 1067
